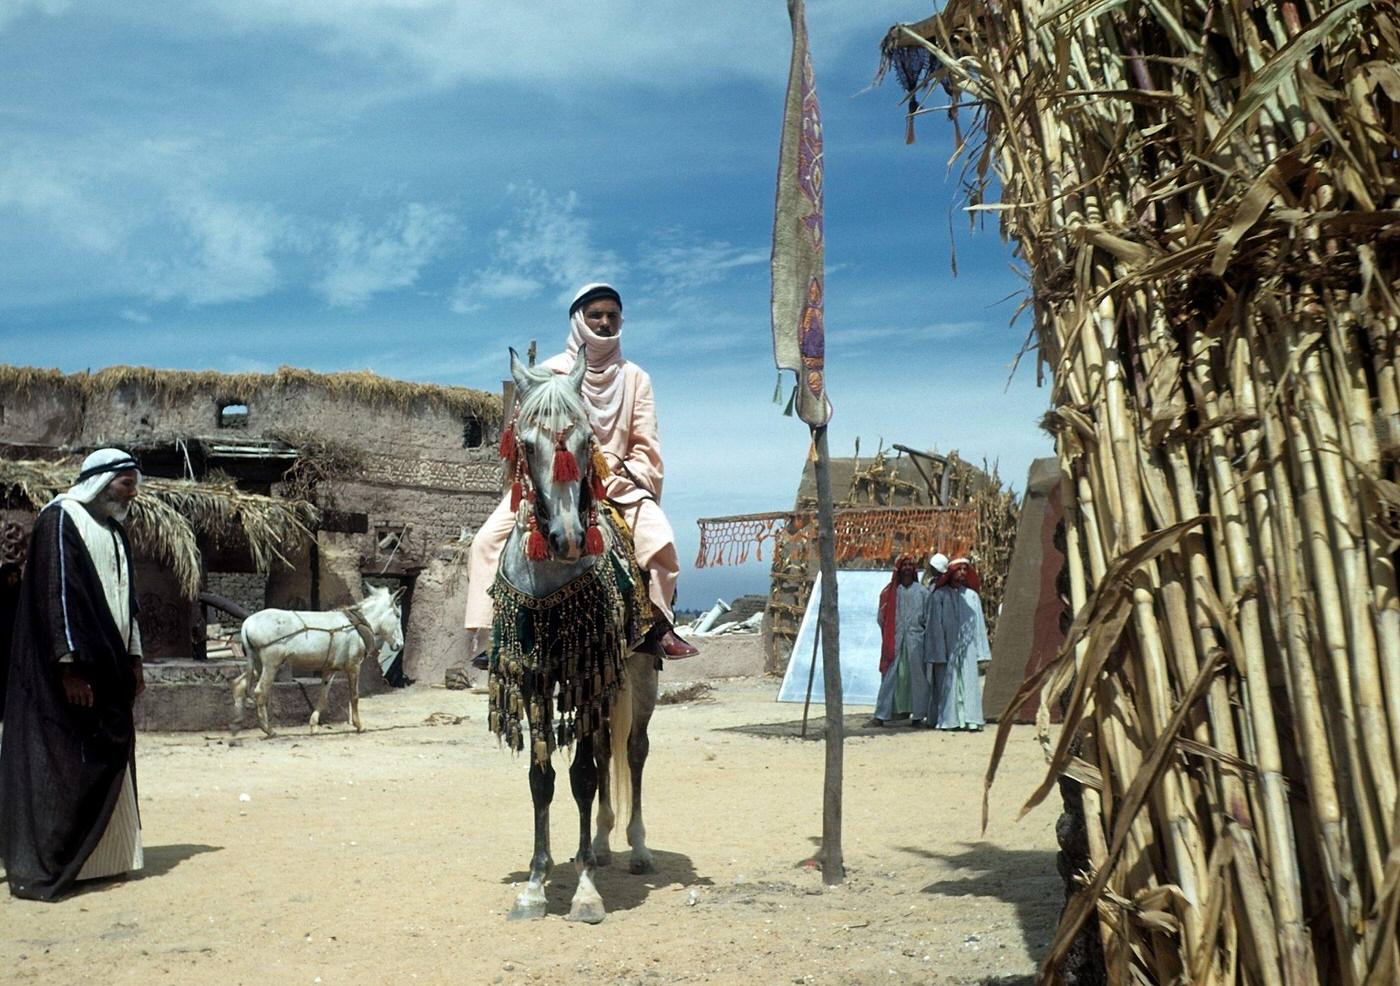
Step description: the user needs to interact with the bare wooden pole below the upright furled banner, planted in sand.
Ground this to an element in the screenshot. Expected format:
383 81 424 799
812 424 846 887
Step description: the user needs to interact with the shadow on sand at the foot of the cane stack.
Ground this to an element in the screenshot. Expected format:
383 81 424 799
900 842 1064 969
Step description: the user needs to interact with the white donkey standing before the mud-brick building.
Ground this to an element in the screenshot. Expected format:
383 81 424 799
232 587 403 735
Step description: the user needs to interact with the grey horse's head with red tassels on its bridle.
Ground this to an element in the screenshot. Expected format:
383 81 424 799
503 349 598 562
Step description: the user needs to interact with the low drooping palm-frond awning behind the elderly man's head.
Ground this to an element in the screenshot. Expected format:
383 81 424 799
0 459 316 599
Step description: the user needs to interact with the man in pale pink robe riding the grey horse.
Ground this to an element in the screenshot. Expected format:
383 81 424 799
466 283 699 657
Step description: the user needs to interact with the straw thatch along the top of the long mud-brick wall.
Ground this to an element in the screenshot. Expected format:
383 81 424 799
0 366 501 423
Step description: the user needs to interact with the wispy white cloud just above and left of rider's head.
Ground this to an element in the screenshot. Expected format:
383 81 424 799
452 183 626 314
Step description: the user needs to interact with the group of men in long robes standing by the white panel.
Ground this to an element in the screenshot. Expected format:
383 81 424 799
871 553 991 730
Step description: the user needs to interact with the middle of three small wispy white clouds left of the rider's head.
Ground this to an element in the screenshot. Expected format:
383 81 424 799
314 202 456 307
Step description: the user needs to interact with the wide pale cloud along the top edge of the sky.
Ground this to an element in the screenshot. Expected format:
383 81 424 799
166 0 884 90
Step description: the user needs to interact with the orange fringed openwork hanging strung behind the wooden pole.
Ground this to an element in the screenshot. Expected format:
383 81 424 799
696 507 977 569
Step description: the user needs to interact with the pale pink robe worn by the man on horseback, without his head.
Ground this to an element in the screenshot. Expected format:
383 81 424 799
466 349 680 630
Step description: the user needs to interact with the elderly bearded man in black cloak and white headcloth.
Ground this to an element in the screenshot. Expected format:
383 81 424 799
0 448 146 901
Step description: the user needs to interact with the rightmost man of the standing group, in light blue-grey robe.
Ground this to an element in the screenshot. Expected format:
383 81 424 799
924 559 991 730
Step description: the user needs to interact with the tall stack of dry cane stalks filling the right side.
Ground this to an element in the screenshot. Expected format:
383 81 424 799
885 0 1400 986
